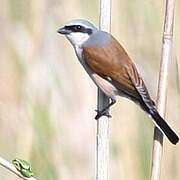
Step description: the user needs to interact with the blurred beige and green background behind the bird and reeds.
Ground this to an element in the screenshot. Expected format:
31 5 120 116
0 0 180 180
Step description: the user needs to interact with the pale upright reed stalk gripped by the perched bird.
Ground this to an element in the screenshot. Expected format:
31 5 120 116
96 0 111 180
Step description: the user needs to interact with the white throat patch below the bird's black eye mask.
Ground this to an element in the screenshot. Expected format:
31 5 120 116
66 32 89 47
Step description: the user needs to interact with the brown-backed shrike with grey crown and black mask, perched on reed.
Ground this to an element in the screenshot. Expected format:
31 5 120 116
57 19 179 144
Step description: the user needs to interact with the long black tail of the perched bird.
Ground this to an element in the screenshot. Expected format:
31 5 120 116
149 108 179 144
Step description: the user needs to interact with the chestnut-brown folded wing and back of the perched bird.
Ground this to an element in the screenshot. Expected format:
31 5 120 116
83 36 154 106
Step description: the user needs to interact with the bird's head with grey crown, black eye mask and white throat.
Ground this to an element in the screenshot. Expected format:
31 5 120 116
57 19 98 46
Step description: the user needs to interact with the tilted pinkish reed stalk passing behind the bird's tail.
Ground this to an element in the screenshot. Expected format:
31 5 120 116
151 0 175 180
